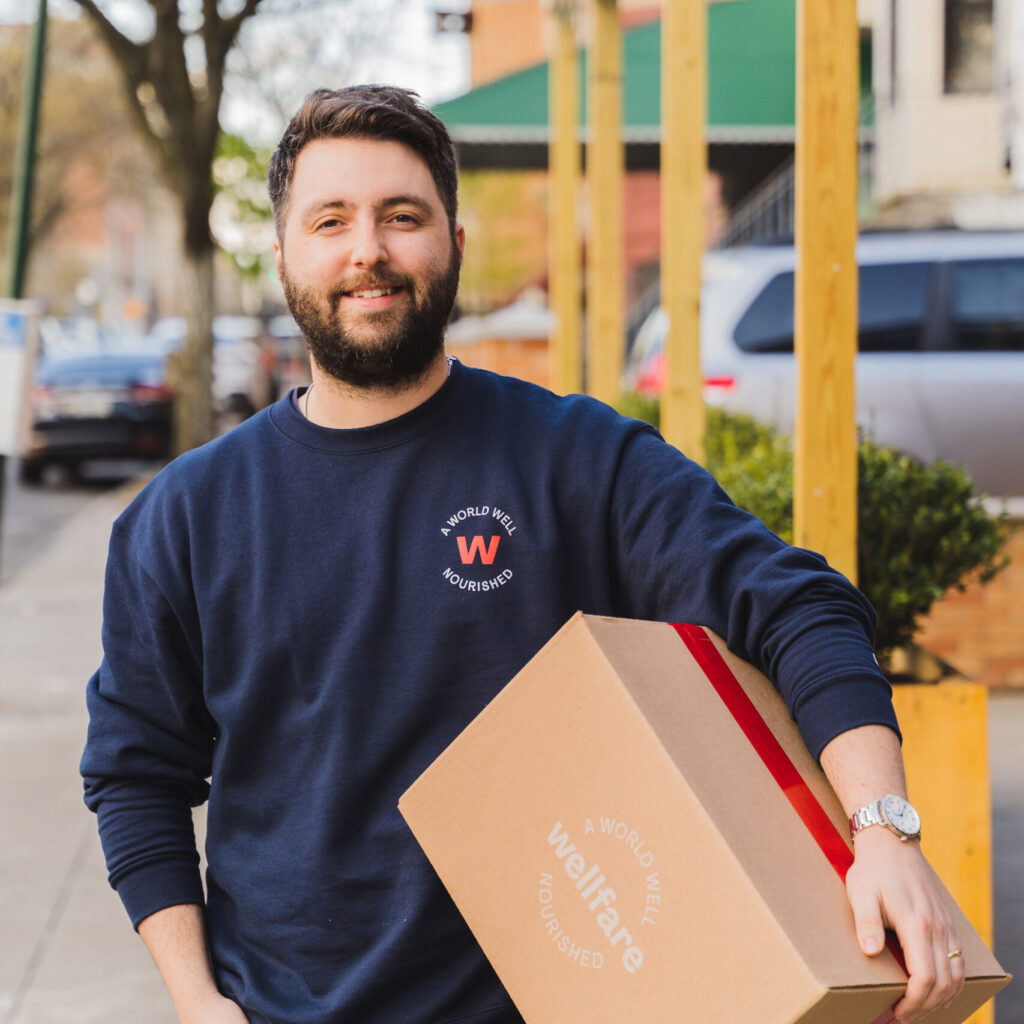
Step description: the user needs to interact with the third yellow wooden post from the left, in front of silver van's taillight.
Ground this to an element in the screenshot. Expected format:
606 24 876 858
662 0 708 462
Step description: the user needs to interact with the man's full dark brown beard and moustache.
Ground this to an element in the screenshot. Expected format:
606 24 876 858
281 245 461 391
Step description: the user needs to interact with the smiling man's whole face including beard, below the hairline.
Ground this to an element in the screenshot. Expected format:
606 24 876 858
274 138 465 389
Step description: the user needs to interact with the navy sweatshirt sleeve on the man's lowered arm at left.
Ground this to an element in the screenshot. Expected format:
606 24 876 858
81 522 214 928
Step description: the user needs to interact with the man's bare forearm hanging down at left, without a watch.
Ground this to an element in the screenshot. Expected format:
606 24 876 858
138 903 245 1024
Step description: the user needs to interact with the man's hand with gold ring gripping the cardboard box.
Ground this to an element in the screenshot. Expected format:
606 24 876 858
846 825 966 1021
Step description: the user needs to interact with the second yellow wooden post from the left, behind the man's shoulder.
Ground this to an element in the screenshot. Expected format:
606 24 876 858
587 0 625 402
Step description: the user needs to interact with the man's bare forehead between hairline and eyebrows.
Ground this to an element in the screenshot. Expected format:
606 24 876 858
291 138 442 213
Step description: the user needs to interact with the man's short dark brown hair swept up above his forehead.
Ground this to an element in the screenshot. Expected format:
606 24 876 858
267 85 459 238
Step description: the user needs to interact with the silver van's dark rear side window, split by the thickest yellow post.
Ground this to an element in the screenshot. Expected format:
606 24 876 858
734 263 931 352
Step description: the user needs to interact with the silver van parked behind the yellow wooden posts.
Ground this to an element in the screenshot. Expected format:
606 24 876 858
624 231 1024 497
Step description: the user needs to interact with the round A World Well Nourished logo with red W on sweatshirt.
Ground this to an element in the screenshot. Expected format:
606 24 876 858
441 505 517 593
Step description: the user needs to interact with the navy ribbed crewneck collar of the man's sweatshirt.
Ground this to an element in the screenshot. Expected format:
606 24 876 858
269 360 468 455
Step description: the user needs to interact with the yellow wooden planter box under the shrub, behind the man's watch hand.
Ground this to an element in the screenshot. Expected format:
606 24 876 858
893 682 994 1024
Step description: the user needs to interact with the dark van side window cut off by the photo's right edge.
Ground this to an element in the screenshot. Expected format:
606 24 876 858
949 258 1024 352
